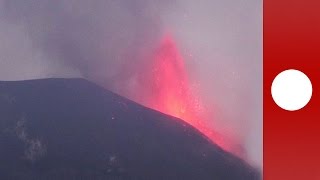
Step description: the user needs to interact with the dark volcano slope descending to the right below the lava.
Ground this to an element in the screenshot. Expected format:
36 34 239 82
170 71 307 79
0 79 258 180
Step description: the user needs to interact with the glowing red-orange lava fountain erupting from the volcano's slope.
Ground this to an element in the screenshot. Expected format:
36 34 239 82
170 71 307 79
139 36 231 151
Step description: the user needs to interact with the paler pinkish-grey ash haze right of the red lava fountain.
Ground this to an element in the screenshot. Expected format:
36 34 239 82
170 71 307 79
165 0 262 167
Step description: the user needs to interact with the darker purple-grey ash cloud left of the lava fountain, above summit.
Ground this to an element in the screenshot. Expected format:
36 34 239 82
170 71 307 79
1 0 165 83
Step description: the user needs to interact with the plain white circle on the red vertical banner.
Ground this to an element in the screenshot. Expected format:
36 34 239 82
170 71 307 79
271 69 312 111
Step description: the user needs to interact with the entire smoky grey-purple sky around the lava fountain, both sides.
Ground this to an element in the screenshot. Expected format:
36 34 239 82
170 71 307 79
0 0 262 167
